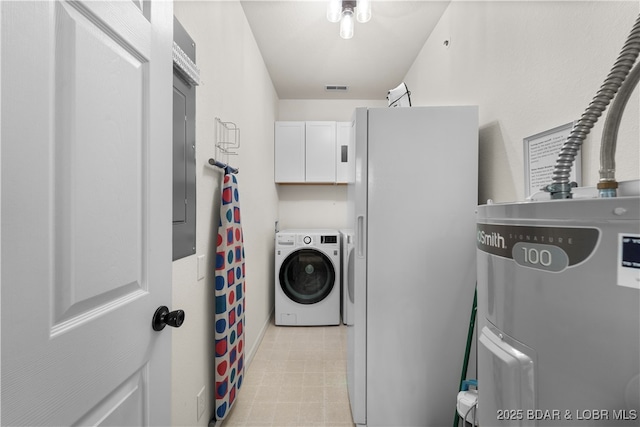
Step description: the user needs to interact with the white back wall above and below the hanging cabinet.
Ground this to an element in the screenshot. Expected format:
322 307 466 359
278 99 387 230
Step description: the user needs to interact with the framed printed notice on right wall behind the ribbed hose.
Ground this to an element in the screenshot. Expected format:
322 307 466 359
523 122 582 198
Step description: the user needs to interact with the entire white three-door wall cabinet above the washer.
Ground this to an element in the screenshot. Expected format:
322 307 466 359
275 121 355 184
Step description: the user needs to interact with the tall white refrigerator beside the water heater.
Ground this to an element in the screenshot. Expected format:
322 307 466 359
347 106 478 427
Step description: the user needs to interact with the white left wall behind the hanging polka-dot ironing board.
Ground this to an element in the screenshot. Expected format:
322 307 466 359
172 1 278 426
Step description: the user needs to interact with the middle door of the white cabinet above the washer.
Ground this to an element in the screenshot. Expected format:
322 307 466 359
305 122 336 182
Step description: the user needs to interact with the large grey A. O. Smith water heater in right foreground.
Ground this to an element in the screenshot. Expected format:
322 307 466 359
476 193 640 427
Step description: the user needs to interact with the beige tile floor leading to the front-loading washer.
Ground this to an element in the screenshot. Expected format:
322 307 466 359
222 320 354 427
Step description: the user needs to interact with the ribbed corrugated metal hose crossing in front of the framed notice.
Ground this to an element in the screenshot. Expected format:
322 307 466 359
545 15 640 199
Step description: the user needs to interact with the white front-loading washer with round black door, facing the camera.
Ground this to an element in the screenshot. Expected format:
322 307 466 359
275 229 342 326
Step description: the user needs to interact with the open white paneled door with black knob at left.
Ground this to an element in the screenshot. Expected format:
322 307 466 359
0 0 173 426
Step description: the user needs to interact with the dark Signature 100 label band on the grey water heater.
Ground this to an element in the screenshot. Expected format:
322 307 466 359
476 224 600 271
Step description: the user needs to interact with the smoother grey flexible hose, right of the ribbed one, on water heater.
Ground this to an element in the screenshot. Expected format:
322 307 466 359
598 61 640 197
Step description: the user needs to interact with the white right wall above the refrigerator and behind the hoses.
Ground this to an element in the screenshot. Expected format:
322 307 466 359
405 1 640 202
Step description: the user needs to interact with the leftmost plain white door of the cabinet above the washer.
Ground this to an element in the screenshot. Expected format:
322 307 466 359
275 122 306 182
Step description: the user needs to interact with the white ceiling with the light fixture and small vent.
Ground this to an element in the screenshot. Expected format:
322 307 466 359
241 0 450 99
